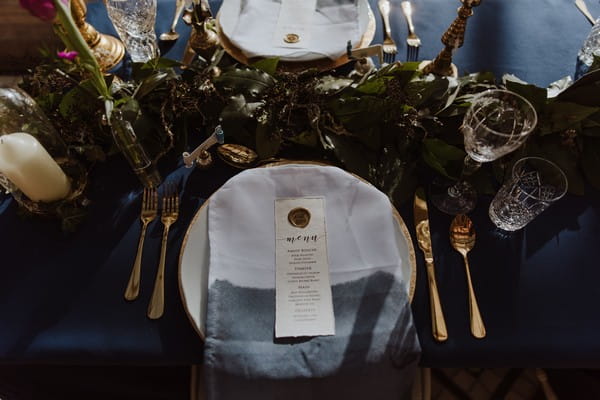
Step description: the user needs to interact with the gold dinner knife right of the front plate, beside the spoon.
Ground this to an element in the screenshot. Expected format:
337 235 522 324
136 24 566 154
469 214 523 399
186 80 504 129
414 188 448 342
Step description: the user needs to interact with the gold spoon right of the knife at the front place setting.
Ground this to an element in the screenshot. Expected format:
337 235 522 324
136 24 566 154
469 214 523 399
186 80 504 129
450 215 485 339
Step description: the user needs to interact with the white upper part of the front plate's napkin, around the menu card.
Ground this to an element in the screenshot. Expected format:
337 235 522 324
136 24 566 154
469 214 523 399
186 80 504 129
208 165 404 289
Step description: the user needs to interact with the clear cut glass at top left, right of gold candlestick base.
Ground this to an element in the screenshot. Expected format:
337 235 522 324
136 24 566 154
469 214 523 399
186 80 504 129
104 0 159 62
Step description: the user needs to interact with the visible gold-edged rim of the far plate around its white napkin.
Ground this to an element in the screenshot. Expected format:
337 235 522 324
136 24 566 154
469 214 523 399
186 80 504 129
216 3 377 72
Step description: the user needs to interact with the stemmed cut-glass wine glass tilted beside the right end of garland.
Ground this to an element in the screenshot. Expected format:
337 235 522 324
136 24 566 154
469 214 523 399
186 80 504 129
431 89 537 215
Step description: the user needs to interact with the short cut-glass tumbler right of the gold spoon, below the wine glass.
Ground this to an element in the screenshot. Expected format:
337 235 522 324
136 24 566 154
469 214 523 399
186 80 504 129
489 157 568 231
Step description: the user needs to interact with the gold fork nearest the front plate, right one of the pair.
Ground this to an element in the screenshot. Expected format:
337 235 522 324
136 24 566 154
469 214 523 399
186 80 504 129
148 185 179 319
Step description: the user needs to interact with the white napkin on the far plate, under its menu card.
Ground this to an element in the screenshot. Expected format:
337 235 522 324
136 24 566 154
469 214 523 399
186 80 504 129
218 0 368 61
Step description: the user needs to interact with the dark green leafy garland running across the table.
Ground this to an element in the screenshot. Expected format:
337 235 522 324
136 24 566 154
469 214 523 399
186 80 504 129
17 49 600 220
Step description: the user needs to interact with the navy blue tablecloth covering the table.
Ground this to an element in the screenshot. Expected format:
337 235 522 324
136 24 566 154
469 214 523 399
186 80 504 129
0 0 600 367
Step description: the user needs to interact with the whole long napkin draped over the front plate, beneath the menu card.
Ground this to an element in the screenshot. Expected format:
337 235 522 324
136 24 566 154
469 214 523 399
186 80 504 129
204 165 420 399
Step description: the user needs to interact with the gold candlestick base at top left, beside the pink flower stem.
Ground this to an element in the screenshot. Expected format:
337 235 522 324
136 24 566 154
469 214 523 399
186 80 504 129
71 0 125 72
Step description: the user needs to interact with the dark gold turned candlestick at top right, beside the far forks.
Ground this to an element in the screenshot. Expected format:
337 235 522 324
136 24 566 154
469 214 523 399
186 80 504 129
421 0 481 76
